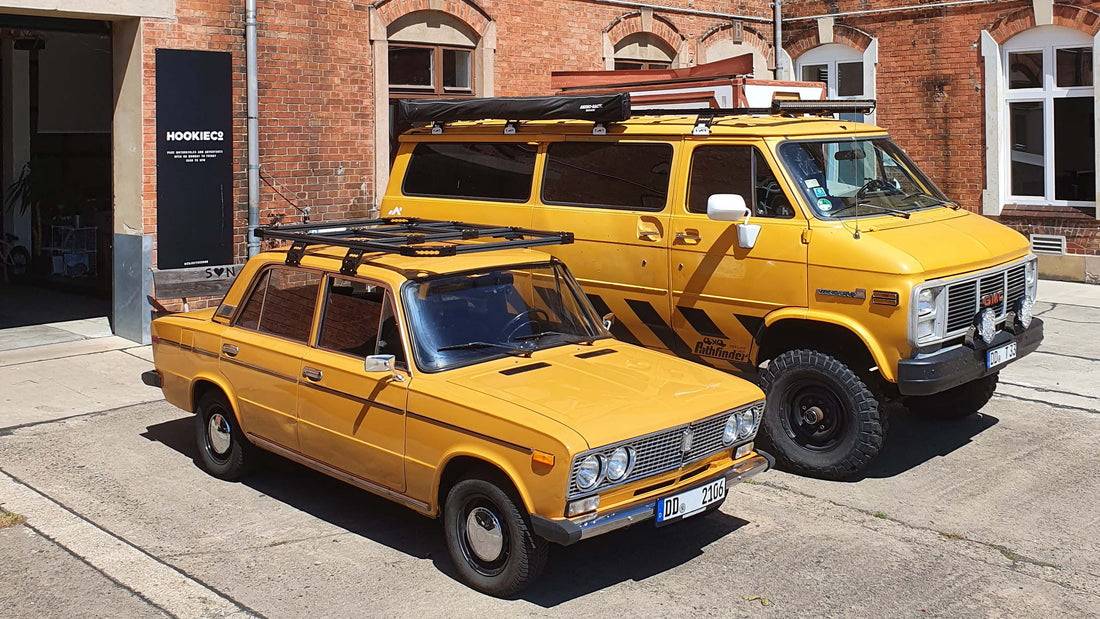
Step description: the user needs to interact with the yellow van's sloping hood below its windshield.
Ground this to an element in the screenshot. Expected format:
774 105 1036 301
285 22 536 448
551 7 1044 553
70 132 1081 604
827 208 1029 279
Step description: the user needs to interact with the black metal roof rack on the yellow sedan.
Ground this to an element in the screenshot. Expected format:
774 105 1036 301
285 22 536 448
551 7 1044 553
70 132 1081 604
254 217 573 275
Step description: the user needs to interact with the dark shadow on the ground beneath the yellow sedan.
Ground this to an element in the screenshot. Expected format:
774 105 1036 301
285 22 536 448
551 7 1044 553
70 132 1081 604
141 417 747 608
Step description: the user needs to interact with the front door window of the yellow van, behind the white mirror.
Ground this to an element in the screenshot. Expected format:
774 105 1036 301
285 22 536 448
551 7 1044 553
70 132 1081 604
688 146 794 219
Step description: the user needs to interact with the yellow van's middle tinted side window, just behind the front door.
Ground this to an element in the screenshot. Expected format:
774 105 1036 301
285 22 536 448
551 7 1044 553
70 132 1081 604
542 142 672 211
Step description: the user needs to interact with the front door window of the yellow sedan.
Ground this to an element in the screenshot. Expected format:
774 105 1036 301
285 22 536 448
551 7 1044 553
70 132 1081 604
317 277 386 357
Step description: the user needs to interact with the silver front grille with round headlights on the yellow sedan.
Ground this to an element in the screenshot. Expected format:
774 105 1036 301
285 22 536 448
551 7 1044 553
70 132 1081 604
569 409 759 498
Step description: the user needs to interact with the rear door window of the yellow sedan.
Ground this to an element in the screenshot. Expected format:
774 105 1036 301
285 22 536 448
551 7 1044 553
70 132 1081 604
237 268 321 343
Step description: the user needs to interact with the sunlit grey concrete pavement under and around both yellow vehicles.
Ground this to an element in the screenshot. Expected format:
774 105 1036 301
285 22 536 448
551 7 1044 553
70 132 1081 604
0 280 1100 617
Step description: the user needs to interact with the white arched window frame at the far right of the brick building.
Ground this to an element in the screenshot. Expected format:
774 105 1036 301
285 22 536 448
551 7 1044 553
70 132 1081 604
1000 25 1100 207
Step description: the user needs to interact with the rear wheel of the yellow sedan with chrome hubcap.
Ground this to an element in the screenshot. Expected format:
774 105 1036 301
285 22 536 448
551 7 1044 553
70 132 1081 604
195 391 255 482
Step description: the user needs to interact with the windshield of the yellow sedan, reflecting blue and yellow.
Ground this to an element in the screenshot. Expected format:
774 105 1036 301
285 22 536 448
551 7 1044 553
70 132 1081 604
402 264 608 372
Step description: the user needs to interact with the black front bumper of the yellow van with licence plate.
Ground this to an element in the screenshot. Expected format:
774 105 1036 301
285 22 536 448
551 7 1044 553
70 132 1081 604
898 318 1043 396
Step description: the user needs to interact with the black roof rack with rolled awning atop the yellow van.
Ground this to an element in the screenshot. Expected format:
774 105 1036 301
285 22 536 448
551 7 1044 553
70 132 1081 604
397 92 876 134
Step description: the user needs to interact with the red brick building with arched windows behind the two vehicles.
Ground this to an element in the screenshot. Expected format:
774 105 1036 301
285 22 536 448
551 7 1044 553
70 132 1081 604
0 0 1100 341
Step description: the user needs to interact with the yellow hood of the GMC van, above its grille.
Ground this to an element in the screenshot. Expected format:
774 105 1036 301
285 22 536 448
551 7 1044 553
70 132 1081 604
846 208 1027 279
